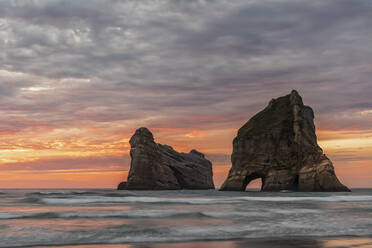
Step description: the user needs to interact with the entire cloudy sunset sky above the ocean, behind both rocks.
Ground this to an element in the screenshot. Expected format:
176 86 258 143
0 0 372 188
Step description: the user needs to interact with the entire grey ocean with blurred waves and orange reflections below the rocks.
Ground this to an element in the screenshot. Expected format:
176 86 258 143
0 189 372 248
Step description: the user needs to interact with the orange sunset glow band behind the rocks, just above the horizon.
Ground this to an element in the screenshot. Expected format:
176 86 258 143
0 121 372 188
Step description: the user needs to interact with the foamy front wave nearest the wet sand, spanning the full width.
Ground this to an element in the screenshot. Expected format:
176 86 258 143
0 222 371 248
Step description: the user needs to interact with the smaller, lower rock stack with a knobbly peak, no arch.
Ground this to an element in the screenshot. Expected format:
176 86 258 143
118 127 214 190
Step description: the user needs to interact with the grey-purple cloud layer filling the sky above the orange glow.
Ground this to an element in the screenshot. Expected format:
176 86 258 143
0 0 372 134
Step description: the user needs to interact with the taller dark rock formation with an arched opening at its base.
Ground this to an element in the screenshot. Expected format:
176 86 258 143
220 91 350 191
